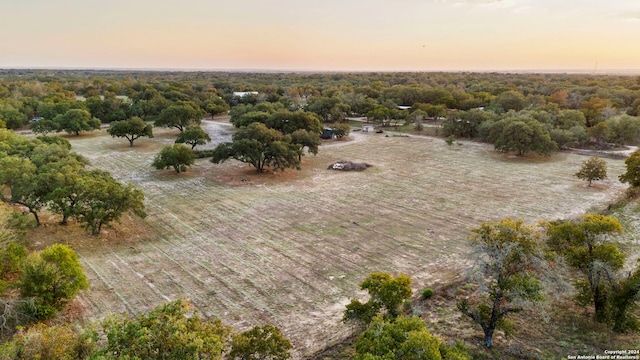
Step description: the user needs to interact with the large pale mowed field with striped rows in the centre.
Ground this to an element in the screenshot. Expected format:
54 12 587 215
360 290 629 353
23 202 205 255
60 121 625 358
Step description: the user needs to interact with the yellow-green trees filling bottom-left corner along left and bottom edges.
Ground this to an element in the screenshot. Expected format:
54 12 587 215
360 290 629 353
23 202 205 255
0 209 292 360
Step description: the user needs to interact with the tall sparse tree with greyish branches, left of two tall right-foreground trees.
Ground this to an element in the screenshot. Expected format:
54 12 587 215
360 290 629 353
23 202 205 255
458 219 549 347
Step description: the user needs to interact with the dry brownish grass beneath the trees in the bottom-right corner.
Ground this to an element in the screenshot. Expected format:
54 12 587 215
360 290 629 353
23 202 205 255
414 276 640 359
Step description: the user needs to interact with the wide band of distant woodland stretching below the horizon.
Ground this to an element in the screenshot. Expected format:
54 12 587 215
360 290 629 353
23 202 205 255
0 70 640 159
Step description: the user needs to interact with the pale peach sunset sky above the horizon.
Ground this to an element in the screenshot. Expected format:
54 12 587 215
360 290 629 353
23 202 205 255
0 0 640 72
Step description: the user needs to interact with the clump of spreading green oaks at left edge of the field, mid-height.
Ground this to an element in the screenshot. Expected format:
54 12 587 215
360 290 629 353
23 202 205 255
0 129 145 235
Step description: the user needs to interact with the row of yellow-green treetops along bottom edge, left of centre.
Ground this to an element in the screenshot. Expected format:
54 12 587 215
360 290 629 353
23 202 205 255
0 300 291 360
